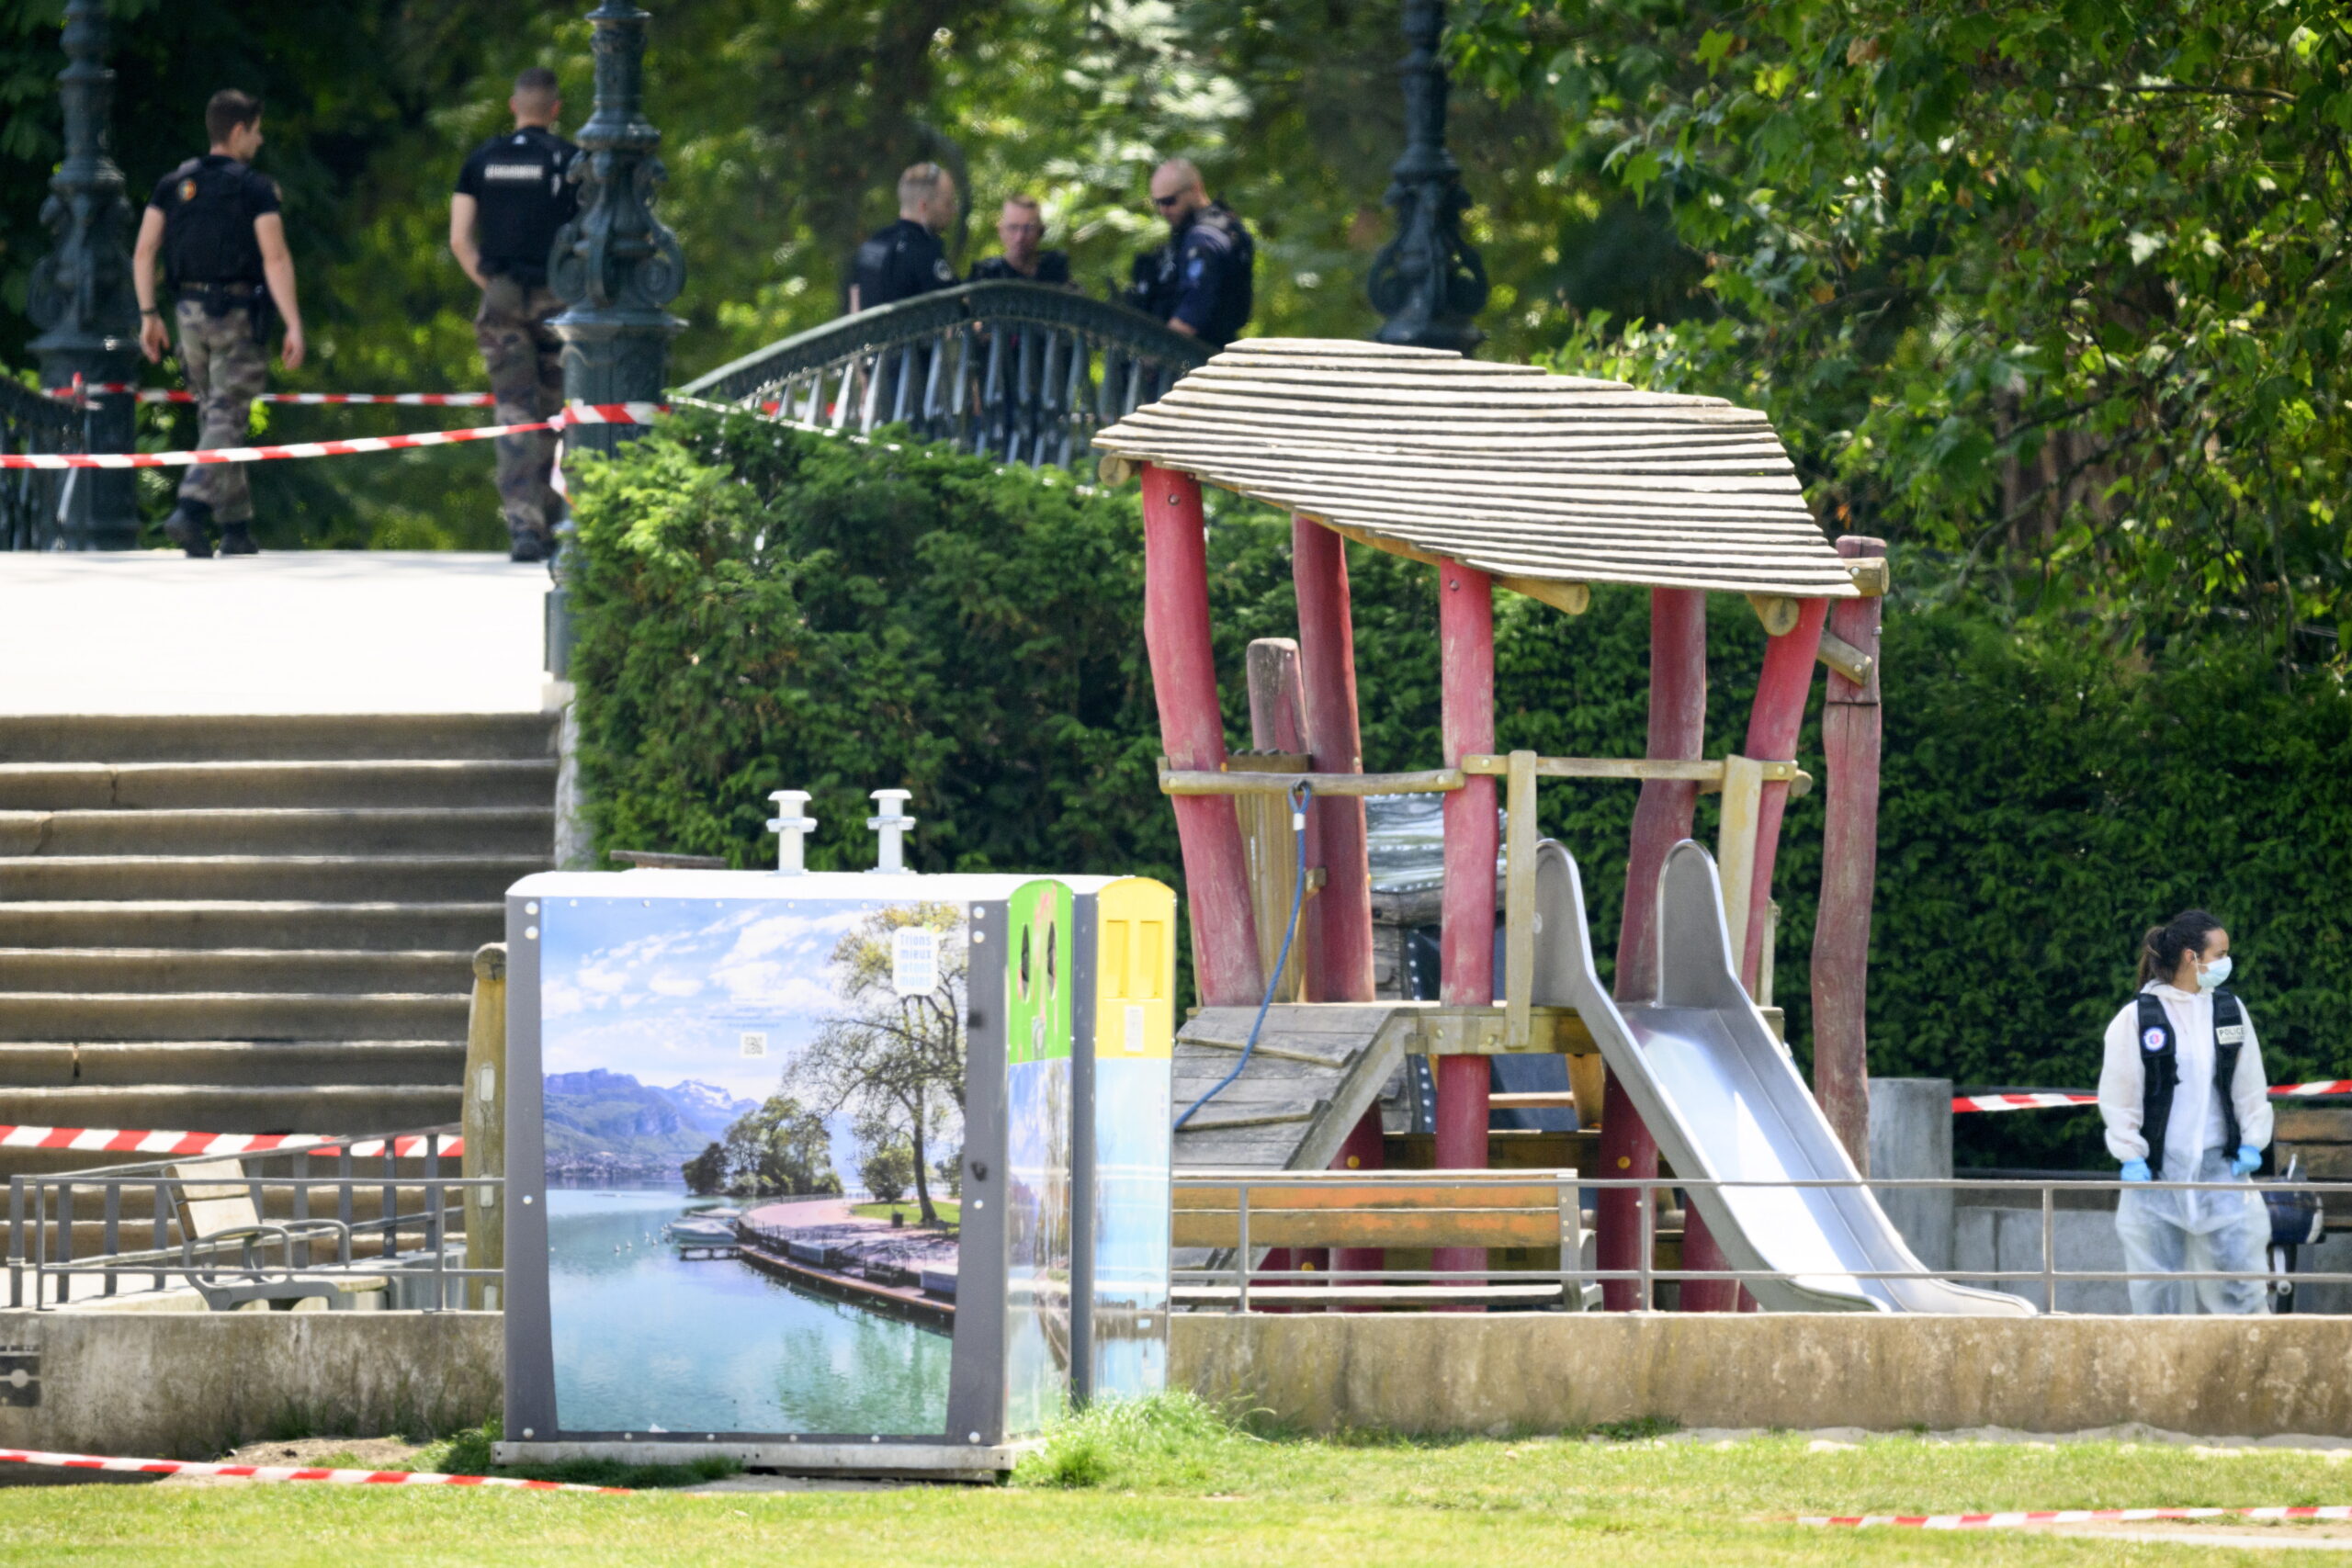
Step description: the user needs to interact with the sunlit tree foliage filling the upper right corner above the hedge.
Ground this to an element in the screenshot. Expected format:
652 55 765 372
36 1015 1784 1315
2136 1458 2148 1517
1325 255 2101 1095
1461 0 2352 663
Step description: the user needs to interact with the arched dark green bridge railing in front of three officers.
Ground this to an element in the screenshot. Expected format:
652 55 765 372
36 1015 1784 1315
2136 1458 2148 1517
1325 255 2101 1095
680 282 1211 468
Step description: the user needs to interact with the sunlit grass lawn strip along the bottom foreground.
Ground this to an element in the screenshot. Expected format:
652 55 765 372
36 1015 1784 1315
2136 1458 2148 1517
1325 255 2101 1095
0 1404 2352 1568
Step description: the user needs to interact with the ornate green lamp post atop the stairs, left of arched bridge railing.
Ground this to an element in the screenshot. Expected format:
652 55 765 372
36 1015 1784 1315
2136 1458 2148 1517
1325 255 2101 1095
548 0 687 677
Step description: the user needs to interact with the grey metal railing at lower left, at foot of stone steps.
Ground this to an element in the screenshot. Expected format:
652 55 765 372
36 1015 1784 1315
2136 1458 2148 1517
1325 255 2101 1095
7 1126 492 1312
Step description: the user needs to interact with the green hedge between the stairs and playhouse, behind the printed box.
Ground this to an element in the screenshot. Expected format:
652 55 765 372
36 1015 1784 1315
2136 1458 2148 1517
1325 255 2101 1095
574 413 1176 874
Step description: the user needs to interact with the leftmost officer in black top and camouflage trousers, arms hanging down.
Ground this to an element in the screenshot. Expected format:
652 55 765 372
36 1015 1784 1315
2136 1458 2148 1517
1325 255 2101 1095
131 87 303 558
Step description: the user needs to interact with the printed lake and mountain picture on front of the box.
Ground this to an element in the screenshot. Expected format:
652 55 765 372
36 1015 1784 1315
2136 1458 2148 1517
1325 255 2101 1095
541 898 967 1437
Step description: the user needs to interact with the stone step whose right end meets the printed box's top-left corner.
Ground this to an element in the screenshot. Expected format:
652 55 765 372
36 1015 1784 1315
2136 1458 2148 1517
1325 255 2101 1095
0 898 505 952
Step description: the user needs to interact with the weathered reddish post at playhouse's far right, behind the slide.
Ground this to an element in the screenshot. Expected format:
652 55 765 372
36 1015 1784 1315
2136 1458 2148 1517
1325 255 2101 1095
1814 534 1886 1176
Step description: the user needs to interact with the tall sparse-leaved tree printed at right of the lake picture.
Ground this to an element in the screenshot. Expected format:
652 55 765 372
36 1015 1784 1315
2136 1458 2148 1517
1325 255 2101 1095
793 903 969 1224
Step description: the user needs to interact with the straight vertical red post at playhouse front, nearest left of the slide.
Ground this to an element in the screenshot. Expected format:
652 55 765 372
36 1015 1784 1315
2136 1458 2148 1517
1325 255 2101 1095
1430 562 1498 1297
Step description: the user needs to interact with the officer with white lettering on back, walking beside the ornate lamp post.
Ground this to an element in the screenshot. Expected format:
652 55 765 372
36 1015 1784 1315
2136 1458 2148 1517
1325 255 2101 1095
449 66 579 562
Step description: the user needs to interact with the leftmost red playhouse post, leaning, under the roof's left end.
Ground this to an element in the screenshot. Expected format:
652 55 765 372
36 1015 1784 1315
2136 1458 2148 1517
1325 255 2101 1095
1143 463 1265 1006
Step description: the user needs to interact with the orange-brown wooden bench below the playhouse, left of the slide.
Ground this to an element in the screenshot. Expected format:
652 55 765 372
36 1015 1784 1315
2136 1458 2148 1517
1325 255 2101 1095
1171 1170 1679 1312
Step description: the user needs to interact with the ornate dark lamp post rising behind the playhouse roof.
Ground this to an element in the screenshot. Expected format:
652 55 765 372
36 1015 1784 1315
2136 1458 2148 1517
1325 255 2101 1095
1369 0 1487 353
